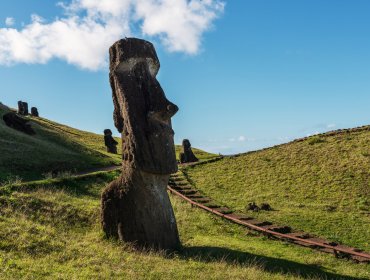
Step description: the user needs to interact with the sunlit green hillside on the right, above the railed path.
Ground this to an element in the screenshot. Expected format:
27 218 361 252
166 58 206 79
185 127 370 251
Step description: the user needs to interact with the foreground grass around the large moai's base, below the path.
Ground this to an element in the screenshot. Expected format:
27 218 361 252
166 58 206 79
0 172 370 280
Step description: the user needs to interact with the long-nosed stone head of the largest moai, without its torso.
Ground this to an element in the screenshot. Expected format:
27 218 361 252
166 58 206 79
109 38 178 174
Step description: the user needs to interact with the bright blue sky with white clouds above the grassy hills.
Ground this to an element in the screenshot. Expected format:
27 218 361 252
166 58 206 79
0 0 370 154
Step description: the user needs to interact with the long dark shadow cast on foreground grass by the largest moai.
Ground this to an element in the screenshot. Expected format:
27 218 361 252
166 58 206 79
178 246 366 280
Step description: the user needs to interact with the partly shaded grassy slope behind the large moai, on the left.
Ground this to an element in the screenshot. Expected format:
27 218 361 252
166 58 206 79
0 104 214 183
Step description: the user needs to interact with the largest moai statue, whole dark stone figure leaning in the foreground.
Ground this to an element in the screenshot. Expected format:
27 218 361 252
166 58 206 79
102 38 180 250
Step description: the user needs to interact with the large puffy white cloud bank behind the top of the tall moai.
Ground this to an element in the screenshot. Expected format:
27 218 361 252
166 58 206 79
0 0 224 70
